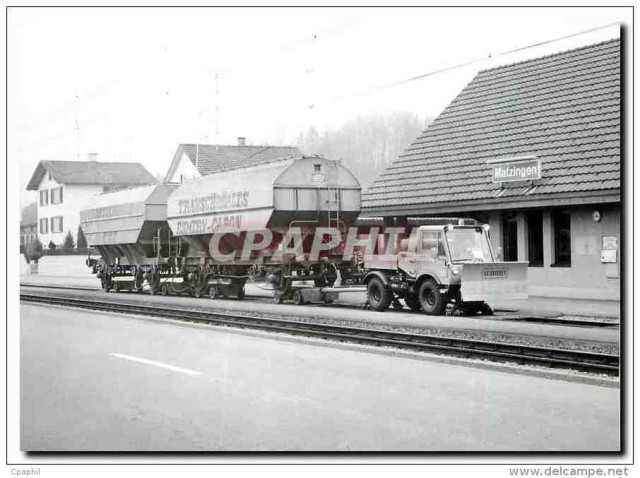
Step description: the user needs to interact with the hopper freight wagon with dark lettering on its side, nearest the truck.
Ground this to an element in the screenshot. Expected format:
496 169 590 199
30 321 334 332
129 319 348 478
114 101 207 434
167 156 360 300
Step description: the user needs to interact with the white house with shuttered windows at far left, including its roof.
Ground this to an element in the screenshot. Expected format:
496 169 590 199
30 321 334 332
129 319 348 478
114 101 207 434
27 161 157 247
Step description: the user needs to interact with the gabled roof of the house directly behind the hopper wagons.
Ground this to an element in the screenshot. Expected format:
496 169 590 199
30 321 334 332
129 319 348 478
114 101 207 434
165 144 302 181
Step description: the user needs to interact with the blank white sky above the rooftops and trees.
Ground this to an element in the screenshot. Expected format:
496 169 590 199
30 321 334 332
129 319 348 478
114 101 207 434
8 8 631 205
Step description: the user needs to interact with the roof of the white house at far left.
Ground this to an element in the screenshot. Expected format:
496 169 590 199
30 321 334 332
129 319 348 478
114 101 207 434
27 161 158 191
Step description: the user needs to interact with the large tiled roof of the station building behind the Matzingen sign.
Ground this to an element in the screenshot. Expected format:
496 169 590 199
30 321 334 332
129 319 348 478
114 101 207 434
363 40 620 211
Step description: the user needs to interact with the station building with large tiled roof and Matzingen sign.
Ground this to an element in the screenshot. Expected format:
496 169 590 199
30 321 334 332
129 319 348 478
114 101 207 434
363 39 621 300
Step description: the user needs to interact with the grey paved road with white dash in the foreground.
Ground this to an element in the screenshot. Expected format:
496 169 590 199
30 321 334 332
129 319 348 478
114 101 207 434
21 304 619 451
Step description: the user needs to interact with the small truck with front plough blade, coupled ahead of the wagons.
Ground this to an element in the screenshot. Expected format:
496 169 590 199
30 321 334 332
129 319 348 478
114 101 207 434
365 221 528 315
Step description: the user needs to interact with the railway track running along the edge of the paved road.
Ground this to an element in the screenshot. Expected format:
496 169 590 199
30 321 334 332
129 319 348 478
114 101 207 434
20 293 619 376
